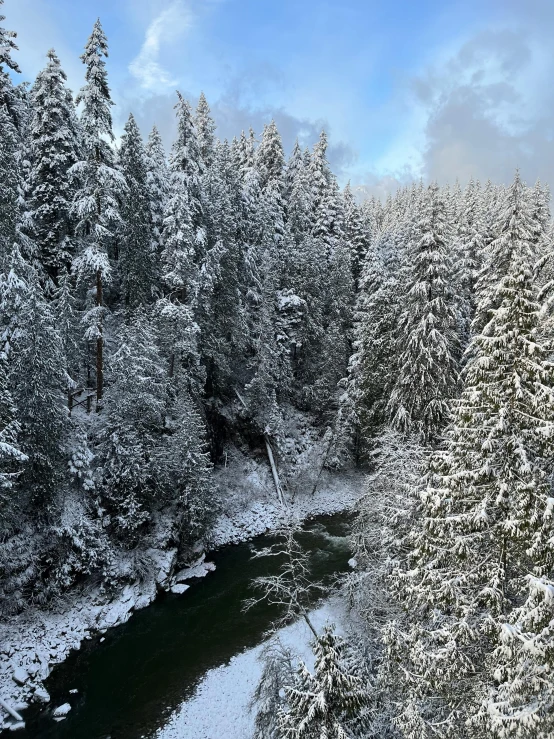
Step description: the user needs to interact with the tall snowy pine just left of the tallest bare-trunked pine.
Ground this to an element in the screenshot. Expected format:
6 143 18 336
26 49 80 283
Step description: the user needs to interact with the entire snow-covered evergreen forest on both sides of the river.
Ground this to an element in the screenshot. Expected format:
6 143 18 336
0 0 554 739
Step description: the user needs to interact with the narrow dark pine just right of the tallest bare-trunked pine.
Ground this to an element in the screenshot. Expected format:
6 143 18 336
118 114 157 308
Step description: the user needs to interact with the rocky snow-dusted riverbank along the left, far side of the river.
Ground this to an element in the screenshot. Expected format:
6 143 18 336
0 462 363 729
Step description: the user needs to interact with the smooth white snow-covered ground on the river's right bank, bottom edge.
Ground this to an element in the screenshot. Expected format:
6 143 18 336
155 599 345 739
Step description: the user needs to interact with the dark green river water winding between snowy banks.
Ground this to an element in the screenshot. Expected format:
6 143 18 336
17 515 350 739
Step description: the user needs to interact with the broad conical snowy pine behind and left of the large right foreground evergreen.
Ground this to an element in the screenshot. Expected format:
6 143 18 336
388 185 459 438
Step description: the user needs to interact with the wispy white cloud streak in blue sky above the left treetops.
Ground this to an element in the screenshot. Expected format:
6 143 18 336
129 0 193 92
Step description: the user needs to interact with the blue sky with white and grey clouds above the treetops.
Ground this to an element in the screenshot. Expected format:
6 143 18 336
7 0 554 197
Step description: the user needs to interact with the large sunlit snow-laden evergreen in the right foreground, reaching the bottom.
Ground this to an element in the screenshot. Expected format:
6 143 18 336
385 189 554 739
